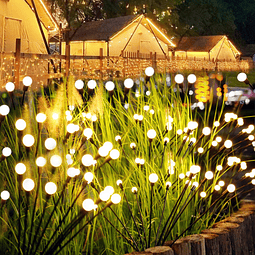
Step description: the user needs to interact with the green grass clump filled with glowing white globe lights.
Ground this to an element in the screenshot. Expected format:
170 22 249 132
0 70 255 255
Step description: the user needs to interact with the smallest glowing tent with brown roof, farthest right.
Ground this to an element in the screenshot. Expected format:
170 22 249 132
175 35 241 61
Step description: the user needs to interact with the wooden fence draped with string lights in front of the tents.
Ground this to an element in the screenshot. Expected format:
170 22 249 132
0 39 253 90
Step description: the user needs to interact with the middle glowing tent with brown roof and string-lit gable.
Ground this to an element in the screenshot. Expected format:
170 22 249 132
62 14 175 56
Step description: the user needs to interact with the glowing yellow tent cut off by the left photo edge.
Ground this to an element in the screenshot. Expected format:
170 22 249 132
0 0 58 53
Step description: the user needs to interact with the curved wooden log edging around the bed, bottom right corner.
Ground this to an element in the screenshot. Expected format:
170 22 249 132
126 201 255 255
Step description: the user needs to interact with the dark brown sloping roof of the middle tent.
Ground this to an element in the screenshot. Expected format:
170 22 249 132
72 15 137 41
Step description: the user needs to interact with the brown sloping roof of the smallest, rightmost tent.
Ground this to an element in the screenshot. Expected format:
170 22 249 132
175 35 223 52
